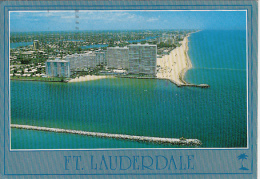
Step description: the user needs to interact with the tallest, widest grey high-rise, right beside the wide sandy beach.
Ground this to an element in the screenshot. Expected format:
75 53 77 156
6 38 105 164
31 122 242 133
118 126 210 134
128 44 157 76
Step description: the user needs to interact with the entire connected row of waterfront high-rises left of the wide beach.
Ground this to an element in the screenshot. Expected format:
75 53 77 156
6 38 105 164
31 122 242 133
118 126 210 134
46 43 157 77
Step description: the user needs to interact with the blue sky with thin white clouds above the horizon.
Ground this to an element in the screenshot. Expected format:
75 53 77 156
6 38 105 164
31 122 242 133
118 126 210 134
10 11 246 32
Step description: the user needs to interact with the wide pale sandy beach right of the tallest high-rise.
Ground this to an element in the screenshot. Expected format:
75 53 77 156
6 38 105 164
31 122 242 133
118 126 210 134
157 35 192 86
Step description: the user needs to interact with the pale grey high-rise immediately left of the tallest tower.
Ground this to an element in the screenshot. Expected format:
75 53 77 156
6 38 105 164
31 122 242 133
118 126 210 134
106 47 129 69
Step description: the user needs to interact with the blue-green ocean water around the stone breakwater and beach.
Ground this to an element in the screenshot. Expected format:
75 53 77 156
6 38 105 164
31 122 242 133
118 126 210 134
11 31 247 149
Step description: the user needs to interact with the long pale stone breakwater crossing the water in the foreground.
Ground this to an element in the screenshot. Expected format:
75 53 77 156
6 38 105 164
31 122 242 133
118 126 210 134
11 124 202 146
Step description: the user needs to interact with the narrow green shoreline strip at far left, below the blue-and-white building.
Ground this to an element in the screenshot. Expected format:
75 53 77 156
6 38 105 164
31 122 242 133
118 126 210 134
11 76 67 82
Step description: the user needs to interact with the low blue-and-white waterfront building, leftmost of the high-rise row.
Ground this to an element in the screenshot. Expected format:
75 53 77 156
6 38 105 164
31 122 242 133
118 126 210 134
45 58 70 77
